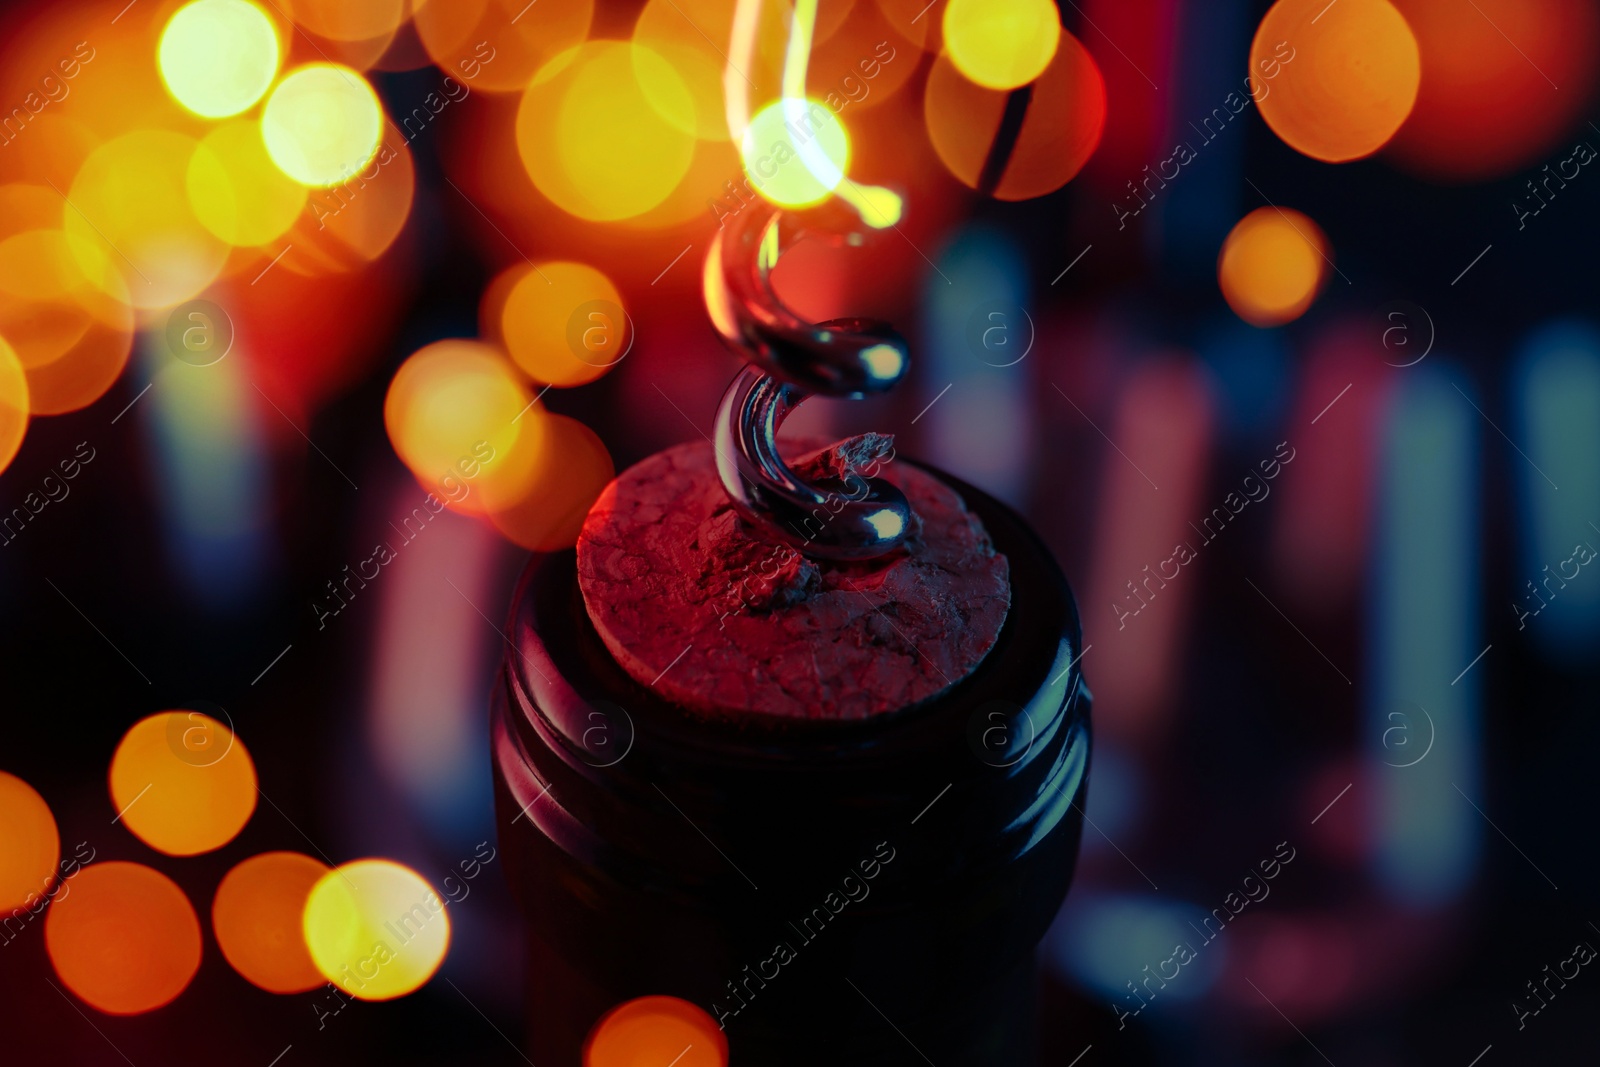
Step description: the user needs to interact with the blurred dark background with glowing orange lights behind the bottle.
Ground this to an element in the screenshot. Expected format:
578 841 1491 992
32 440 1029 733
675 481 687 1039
0 0 1600 1067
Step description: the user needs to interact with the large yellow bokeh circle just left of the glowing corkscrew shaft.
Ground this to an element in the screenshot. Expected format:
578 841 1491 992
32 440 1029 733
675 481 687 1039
518 42 694 222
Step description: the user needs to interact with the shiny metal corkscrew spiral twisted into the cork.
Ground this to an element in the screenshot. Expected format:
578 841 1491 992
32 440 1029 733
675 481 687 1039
706 205 912 561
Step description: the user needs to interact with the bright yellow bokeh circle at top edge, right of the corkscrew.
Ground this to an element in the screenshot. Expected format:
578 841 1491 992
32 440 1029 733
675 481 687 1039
944 0 1061 90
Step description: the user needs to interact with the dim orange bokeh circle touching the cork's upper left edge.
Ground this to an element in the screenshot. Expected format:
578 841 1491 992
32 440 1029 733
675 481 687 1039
490 414 616 552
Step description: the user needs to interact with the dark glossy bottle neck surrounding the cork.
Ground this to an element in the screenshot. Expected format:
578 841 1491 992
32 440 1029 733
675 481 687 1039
493 475 1090 1067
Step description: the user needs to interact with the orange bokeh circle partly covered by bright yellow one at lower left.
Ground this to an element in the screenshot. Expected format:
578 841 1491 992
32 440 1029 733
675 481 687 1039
211 853 330 993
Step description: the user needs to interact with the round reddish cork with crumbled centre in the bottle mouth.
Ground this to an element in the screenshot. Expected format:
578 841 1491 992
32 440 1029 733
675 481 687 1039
578 435 1011 721
